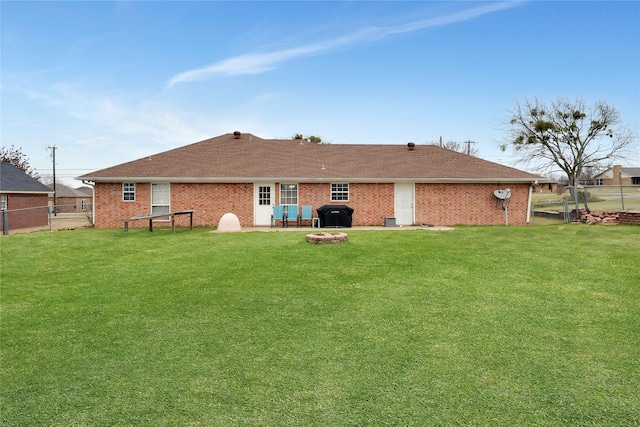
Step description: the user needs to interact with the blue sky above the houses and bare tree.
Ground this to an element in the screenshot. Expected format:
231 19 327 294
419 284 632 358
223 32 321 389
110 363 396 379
0 1 640 185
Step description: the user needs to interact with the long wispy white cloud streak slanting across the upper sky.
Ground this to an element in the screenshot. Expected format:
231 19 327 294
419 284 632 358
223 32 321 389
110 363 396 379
167 2 522 87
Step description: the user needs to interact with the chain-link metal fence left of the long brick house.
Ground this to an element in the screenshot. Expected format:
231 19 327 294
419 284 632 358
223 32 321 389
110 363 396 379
0 203 93 235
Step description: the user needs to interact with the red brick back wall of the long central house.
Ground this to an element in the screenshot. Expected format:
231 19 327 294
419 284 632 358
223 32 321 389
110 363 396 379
95 183 529 228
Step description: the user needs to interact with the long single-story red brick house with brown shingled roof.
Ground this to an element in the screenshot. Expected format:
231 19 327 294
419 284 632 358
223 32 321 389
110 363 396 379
77 132 545 228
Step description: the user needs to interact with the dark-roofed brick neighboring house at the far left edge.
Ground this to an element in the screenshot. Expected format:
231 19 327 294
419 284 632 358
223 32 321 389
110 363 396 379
0 163 51 234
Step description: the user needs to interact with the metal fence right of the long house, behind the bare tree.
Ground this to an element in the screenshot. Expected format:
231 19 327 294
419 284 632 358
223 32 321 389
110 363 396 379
532 185 640 222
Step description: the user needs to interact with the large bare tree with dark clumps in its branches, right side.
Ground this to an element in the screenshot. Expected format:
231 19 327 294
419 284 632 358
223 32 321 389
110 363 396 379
502 98 635 211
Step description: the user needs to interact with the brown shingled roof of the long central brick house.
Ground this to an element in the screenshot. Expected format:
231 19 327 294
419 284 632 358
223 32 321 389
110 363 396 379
77 133 542 182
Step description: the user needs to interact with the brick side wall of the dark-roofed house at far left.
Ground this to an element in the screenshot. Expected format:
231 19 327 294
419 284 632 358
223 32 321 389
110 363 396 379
6 194 49 230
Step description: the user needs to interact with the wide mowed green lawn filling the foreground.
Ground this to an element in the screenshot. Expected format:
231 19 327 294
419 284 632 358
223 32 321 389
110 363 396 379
0 225 640 426
